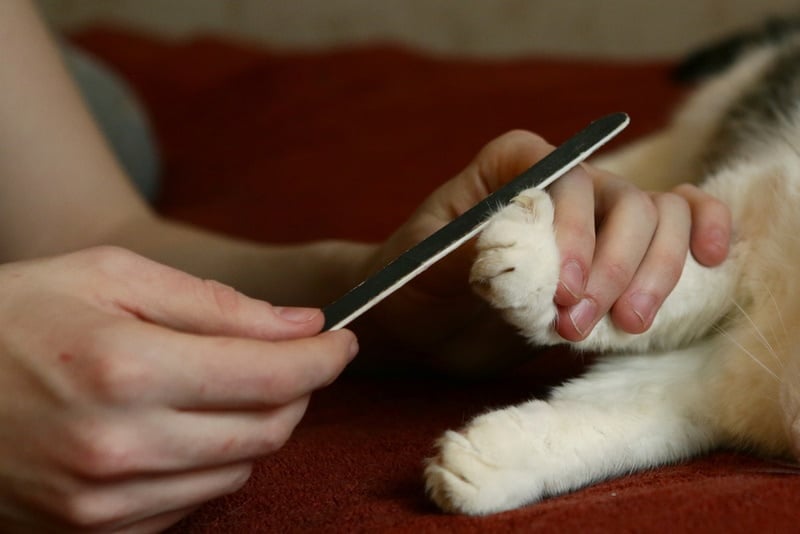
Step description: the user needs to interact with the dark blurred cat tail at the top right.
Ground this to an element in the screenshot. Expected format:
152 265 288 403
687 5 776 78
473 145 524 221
672 15 800 84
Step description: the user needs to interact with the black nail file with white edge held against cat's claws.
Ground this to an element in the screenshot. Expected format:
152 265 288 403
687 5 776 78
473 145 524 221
323 113 630 330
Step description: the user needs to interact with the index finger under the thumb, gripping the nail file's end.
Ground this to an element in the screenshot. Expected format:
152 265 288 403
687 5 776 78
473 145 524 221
76 321 358 409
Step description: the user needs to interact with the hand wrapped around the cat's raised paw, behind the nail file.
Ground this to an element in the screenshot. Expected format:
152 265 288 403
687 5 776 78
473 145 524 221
361 131 731 372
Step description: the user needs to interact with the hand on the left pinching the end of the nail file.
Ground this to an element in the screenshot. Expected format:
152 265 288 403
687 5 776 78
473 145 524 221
0 248 357 532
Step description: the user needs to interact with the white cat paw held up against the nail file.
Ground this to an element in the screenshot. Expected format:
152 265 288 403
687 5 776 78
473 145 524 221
470 189 560 343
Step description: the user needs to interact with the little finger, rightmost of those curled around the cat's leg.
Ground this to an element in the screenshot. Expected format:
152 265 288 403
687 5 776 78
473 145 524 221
674 184 733 267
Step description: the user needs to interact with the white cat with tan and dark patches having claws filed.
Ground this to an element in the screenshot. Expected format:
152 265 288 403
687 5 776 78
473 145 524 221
425 18 800 515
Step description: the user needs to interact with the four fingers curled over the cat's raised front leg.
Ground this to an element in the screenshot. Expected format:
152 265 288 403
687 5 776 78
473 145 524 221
549 161 731 341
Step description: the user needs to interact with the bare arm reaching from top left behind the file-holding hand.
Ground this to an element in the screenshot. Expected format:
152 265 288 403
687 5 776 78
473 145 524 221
0 0 373 305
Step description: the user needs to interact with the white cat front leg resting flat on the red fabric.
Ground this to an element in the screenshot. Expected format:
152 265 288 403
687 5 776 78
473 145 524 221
425 348 717 515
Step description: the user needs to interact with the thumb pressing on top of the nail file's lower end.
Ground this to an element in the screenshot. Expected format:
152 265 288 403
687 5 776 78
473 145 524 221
74 247 324 340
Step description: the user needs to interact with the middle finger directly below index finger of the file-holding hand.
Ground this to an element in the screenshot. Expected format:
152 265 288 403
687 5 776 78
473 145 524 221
57 396 309 481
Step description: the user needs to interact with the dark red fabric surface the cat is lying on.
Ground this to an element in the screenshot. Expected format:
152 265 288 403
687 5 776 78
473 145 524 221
75 30 800 532
